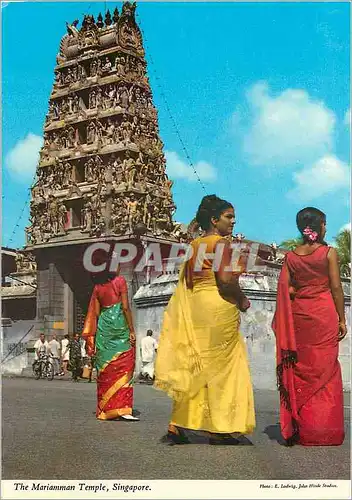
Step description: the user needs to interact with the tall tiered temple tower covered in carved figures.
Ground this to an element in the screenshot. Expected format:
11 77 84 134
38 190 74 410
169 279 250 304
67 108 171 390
27 2 177 334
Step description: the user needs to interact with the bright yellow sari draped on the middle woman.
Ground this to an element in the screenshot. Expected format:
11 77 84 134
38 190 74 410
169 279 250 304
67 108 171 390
154 235 255 434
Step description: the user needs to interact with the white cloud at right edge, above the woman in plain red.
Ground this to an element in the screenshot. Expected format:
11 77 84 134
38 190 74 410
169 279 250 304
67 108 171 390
287 155 350 201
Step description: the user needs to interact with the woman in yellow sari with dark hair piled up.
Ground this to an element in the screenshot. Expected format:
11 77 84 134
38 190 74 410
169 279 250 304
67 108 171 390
155 195 255 445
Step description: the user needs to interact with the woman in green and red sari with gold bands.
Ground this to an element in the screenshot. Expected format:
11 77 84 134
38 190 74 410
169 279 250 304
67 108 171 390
83 272 139 420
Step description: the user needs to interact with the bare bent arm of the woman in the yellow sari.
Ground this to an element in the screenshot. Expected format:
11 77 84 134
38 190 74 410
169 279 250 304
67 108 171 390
215 240 249 311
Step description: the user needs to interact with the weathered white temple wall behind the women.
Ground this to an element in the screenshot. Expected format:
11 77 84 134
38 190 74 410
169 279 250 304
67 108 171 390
134 271 351 391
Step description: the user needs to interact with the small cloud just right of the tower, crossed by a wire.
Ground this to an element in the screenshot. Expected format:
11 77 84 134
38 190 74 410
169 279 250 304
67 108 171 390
165 151 217 182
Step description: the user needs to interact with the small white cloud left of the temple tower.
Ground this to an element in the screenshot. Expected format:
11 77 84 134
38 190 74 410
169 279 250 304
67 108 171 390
5 133 43 182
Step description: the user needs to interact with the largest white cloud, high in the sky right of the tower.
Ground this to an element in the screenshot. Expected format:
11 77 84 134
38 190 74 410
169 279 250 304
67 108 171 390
243 82 336 167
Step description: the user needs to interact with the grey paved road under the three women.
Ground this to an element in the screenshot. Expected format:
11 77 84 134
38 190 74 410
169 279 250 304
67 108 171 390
2 378 350 480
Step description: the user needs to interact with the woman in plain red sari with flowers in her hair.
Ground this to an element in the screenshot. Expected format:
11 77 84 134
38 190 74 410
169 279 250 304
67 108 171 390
273 207 347 446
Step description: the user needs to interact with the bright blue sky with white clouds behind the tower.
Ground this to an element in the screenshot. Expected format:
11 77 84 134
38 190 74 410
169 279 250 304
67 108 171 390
2 2 350 246
